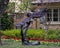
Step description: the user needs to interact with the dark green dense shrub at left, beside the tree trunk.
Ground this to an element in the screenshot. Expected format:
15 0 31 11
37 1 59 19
1 13 12 30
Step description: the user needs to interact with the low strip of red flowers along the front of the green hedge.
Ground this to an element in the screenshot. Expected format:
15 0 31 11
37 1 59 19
1 36 60 42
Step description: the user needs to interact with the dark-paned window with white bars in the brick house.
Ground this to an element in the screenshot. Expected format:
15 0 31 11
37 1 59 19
47 8 60 22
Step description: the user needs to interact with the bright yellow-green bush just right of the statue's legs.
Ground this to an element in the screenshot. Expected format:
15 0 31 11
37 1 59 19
27 29 46 38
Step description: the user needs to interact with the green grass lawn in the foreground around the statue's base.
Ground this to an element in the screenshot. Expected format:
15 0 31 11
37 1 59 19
0 40 60 48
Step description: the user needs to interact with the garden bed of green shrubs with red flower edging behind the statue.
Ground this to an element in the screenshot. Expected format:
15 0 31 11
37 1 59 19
1 29 60 42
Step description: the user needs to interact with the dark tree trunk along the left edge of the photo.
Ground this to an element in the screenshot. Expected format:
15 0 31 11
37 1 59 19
0 0 9 45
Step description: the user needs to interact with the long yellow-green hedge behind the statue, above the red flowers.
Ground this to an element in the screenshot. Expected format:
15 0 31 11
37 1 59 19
3 29 60 40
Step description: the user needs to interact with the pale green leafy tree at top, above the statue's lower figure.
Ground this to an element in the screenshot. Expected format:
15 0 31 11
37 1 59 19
19 0 33 12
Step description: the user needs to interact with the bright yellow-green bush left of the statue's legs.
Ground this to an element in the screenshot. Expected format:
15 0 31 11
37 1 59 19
3 29 21 37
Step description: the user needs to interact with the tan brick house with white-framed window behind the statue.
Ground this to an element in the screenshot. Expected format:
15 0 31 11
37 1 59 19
9 0 60 29
